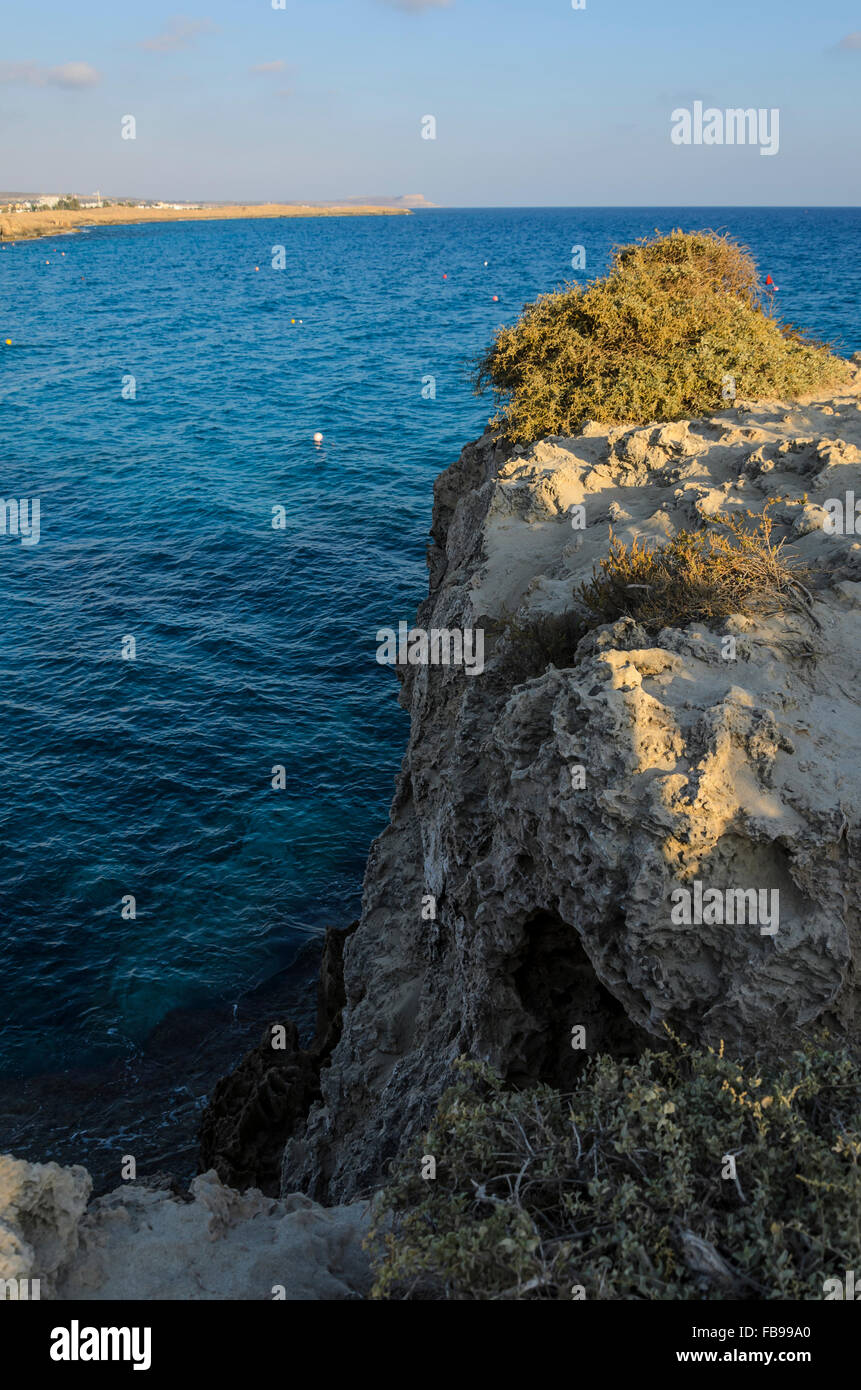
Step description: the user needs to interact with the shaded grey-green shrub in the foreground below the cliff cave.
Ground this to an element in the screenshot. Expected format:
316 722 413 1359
370 1037 861 1300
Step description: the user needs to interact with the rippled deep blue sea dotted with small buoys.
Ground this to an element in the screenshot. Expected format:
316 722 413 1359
0 209 861 1161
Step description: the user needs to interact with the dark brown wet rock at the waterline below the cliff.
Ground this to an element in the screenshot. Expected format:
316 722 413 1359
199 922 357 1197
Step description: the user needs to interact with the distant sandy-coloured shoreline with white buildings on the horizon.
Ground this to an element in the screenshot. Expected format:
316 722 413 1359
0 203 410 242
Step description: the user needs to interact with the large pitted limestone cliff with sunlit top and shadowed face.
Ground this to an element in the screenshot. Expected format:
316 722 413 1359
282 371 861 1201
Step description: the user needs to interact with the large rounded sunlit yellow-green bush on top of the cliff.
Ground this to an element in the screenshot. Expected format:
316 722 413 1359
476 231 848 441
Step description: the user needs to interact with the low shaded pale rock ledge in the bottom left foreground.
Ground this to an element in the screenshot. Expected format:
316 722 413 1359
0 1155 370 1300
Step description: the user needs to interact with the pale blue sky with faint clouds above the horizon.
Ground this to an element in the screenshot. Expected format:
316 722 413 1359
0 0 861 207
